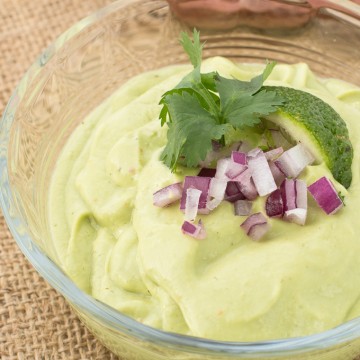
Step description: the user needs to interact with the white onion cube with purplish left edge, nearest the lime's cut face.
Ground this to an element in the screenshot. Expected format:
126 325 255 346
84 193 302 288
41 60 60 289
275 144 315 178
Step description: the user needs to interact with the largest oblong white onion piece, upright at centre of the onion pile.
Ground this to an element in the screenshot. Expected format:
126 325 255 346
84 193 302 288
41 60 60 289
247 148 277 196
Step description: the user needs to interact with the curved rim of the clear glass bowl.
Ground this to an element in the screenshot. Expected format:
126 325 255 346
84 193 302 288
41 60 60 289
0 0 360 358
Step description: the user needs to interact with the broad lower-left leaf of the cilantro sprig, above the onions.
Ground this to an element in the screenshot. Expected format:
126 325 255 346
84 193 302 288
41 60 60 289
161 92 229 170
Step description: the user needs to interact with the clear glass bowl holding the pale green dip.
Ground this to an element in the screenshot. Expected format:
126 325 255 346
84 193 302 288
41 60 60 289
0 0 360 360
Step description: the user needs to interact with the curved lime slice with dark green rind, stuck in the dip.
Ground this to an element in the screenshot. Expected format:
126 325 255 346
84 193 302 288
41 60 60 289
263 86 353 188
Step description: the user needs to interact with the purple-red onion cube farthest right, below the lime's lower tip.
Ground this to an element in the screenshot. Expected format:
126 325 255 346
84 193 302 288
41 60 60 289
308 176 343 215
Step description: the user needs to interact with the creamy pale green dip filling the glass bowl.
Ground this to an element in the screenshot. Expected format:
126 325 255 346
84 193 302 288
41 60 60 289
49 57 360 341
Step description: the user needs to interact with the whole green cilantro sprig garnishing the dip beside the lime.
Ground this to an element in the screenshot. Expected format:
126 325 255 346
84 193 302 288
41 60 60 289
159 29 283 171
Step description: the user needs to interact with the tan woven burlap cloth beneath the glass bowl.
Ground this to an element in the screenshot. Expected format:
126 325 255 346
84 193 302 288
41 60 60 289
0 0 121 360
